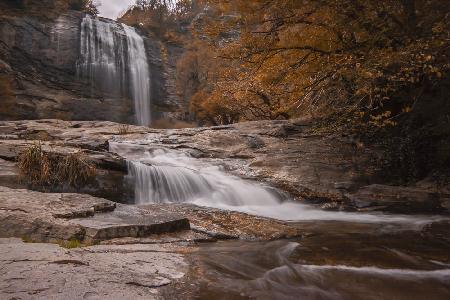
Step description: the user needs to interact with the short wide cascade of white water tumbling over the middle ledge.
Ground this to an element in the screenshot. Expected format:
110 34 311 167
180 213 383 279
110 142 280 207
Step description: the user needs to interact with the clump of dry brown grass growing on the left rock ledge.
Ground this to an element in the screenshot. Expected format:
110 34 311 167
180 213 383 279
18 143 96 187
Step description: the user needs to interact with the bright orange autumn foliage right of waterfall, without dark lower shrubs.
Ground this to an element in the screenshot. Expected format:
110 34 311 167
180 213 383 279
171 0 450 127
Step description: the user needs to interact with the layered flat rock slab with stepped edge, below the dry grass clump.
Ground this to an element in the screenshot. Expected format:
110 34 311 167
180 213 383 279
0 187 189 242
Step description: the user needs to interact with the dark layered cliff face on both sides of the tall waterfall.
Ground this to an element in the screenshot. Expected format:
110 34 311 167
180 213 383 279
0 11 178 123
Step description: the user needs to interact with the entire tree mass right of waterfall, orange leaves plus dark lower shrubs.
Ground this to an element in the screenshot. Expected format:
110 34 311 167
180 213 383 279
120 0 450 183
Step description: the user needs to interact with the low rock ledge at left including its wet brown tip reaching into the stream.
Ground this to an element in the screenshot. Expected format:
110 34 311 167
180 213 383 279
0 187 300 245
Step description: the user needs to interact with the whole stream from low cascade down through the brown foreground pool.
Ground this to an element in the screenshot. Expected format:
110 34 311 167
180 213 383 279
110 142 450 299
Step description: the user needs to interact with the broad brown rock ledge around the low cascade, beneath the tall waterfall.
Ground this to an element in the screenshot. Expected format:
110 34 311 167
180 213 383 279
0 120 450 213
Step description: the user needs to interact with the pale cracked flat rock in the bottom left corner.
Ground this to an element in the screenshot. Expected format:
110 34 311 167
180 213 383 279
0 239 187 300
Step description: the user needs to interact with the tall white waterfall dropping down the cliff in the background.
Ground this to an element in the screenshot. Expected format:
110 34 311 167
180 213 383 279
77 15 151 125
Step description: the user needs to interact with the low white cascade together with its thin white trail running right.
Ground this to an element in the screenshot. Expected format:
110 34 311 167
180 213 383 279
110 142 446 225
